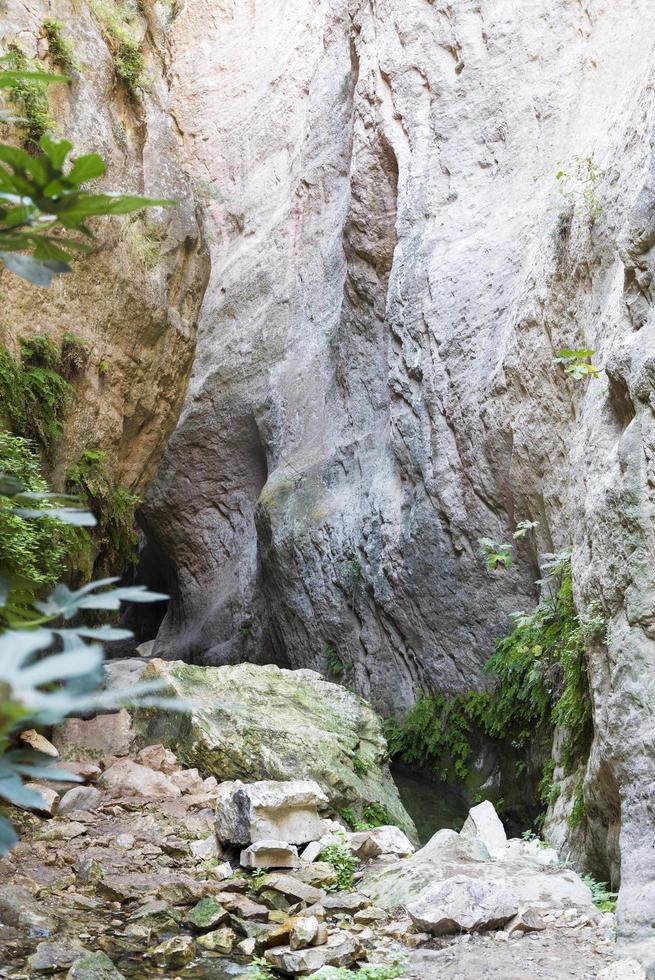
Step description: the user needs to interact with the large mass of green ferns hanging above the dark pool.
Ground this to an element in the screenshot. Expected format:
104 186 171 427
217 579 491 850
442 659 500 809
385 552 604 828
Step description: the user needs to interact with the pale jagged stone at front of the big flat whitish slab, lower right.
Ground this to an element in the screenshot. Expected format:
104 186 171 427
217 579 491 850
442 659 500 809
407 875 518 935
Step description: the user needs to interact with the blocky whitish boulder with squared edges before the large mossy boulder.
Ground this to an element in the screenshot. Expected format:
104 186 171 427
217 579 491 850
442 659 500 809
216 779 328 844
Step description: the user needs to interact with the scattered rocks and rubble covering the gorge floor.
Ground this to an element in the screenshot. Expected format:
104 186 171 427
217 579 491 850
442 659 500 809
0 713 639 980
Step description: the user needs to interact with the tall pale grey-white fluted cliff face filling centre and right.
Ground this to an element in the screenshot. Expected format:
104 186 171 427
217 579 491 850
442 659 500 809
142 0 655 961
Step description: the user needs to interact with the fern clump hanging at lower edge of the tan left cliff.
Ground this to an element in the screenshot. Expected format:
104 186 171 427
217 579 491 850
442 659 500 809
66 449 140 573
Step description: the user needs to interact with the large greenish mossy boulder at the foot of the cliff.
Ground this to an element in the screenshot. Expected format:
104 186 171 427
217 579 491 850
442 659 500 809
134 660 416 840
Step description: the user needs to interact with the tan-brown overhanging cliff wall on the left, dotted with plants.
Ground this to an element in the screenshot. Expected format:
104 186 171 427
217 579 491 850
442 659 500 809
0 0 209 492
